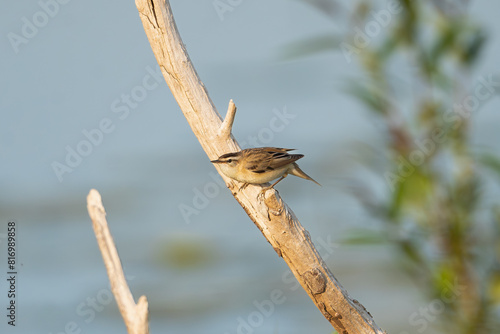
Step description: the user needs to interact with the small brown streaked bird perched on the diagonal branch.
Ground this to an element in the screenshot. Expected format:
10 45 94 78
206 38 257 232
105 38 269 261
211 147 321 191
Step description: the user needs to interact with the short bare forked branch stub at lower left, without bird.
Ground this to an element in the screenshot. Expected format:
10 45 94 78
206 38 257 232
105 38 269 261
87 189 149 334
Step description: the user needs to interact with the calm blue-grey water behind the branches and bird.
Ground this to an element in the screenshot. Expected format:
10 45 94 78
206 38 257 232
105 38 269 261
0 0 500 334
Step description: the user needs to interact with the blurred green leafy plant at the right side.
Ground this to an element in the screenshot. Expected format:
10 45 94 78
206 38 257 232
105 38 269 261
290 0 500 334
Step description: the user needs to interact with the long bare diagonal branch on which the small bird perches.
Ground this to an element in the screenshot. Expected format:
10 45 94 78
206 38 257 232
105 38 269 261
136 0 383 333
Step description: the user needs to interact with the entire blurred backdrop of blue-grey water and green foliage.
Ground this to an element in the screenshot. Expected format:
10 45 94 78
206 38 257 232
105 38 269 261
0 0 500 334
